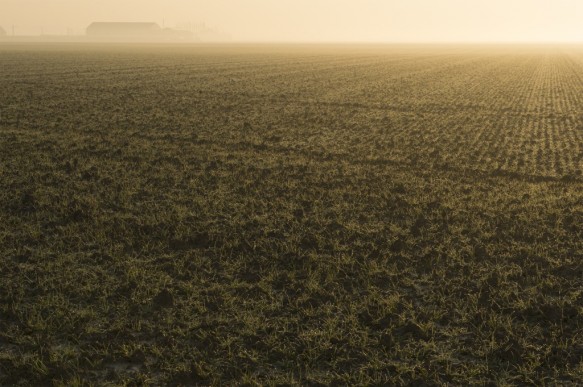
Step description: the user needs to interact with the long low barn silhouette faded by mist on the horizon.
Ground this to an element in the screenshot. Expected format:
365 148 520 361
86 22 193 41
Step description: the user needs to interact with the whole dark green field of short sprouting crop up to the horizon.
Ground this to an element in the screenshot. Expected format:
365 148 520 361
0 44 583 385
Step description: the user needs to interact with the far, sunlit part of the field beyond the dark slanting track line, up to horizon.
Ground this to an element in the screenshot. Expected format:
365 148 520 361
0 44 583 178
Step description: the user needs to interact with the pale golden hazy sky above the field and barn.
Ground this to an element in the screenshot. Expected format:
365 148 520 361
0 0 583 42
